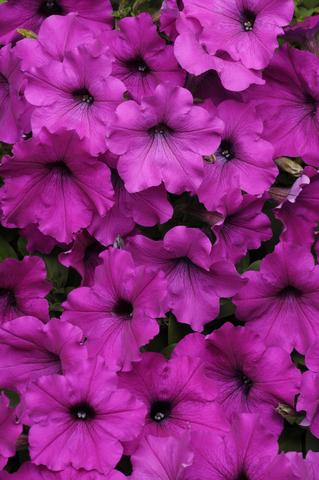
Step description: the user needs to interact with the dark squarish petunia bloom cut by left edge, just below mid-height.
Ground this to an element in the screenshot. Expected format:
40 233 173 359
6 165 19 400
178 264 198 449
0 257 51 325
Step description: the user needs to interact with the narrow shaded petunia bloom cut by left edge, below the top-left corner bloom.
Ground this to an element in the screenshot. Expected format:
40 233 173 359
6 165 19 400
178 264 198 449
0 45 29 143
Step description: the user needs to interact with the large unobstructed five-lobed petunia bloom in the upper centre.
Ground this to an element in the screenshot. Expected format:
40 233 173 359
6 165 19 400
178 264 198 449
108 84 223 193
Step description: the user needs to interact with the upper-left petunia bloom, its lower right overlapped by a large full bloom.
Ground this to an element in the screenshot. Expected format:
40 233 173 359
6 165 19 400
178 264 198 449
25 43 125 154
